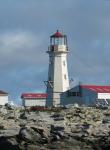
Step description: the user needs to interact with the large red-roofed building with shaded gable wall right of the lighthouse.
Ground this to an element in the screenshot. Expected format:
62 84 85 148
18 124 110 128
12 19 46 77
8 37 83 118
61 85 110 105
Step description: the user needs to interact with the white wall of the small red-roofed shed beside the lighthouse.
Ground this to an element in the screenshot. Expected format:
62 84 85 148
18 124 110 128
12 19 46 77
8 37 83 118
22 99 46 107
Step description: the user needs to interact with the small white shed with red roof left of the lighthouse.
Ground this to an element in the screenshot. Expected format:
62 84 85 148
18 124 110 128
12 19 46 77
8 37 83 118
21 93 47 107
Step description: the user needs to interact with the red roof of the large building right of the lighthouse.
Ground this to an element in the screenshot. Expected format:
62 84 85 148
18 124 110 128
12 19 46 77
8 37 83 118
80 85 110 93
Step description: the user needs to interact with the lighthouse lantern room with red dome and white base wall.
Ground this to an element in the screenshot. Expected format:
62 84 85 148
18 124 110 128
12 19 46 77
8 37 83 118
50 30 67 52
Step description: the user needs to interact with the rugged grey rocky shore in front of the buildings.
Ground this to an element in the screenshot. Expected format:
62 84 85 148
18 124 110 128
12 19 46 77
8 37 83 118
0 105 110 150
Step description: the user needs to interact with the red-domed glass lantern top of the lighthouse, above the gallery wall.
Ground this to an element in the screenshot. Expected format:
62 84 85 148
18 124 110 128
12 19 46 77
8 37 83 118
50 30 67 45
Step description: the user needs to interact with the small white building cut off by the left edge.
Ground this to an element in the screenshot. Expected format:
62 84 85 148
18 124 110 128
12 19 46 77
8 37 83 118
0 91 8 105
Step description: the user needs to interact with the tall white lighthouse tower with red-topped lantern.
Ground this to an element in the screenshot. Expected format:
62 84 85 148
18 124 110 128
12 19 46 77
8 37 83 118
46 30 69 107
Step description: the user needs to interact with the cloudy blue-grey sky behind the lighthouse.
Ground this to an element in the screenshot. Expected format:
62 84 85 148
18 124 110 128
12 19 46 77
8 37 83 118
0 0 110 103
